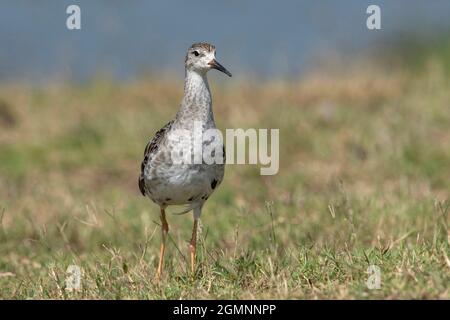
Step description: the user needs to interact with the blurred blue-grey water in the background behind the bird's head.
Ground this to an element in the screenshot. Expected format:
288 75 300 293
0 0 450 82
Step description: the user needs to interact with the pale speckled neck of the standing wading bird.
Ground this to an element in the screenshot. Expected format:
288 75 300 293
177 70 214 127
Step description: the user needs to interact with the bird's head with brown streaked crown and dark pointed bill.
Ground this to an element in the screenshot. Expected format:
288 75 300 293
185 42 231 77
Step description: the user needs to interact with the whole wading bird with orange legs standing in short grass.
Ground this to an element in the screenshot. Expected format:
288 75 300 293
139 42 231 280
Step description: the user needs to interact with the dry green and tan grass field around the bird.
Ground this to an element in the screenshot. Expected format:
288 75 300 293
0 56 450 299
